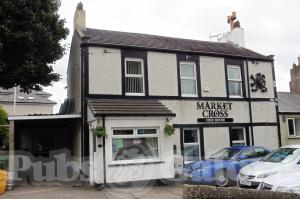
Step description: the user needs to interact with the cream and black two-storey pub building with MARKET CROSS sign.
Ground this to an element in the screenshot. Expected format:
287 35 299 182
68 3 280 184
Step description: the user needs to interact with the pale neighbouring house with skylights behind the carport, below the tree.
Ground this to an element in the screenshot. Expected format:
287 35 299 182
0 88 56 115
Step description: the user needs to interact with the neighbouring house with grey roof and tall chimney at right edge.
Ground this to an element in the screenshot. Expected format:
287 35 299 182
278 57 300 145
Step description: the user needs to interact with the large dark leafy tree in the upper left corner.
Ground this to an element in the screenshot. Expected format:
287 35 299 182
0 0 69 92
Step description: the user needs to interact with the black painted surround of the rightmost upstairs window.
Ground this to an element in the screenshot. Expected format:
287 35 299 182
224 58 246 99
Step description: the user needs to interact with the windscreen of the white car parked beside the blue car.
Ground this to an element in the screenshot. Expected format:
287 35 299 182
261 148 300 163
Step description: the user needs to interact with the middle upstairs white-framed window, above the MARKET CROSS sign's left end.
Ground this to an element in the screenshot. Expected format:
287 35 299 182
180 62 198 97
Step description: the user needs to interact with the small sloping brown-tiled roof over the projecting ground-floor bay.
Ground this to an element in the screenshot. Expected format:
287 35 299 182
88 99 175 116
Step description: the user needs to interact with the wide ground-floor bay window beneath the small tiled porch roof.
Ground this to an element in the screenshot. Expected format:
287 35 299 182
112 128 159 161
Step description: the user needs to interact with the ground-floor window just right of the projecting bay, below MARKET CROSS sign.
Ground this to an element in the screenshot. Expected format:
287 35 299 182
183 128 201 164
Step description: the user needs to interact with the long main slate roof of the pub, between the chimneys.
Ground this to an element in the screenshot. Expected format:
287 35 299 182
83 28 272 61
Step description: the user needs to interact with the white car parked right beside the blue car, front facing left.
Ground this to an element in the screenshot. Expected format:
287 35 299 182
238 145 300 188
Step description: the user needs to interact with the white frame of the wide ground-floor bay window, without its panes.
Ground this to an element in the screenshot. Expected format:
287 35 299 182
110 127 161 164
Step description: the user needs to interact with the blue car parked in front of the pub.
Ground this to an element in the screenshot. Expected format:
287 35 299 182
183 146 270 186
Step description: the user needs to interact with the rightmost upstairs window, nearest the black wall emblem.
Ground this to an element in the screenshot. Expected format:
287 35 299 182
227 65 243 97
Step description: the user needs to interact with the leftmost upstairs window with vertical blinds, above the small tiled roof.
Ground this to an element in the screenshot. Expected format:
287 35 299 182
125 58 145 96
